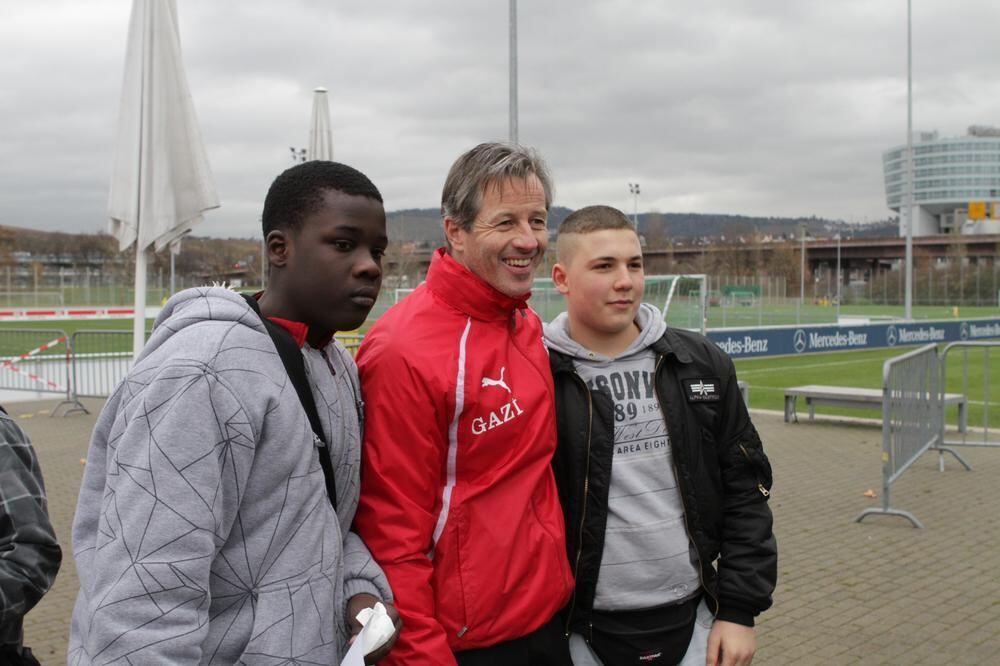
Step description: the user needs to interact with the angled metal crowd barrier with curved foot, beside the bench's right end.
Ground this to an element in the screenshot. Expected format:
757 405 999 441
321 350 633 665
855 344 944 527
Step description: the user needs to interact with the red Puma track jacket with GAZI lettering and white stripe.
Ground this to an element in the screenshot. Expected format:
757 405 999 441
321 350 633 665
355 250 573 666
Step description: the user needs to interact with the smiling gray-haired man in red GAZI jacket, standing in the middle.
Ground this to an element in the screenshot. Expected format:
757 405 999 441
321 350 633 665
355 143 573 666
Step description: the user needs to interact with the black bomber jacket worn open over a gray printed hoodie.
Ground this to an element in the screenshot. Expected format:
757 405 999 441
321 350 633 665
550 327 778 633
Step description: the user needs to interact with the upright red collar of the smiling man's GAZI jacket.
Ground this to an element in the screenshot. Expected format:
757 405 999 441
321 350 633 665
427 247 531 321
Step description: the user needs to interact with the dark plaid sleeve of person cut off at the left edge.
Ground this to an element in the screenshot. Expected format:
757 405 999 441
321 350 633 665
0 414 62 643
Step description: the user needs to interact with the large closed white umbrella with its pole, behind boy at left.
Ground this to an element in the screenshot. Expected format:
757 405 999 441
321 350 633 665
108 0 219 355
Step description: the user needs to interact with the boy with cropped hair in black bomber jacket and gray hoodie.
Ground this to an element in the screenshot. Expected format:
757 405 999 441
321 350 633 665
545 206 777 666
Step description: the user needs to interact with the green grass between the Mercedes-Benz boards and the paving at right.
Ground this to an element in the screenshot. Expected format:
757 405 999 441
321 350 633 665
735 347 1000 428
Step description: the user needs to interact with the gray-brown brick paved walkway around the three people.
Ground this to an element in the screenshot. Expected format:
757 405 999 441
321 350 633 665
10 401 1000 665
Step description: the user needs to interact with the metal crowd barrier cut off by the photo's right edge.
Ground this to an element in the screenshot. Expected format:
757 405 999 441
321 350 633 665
939 340 1000 471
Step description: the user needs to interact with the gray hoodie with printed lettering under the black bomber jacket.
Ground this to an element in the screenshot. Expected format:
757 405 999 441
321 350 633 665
545 303 699 611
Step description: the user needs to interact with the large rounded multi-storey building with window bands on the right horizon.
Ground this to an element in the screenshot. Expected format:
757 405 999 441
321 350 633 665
882 125 1000 236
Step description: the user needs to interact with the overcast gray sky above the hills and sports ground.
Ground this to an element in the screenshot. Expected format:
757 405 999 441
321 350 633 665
0 0 1000 237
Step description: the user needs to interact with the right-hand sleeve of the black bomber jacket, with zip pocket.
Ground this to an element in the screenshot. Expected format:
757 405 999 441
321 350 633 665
718 357 778 627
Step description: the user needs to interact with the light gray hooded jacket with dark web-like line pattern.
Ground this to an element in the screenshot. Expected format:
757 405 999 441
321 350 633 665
69 288 391 664
